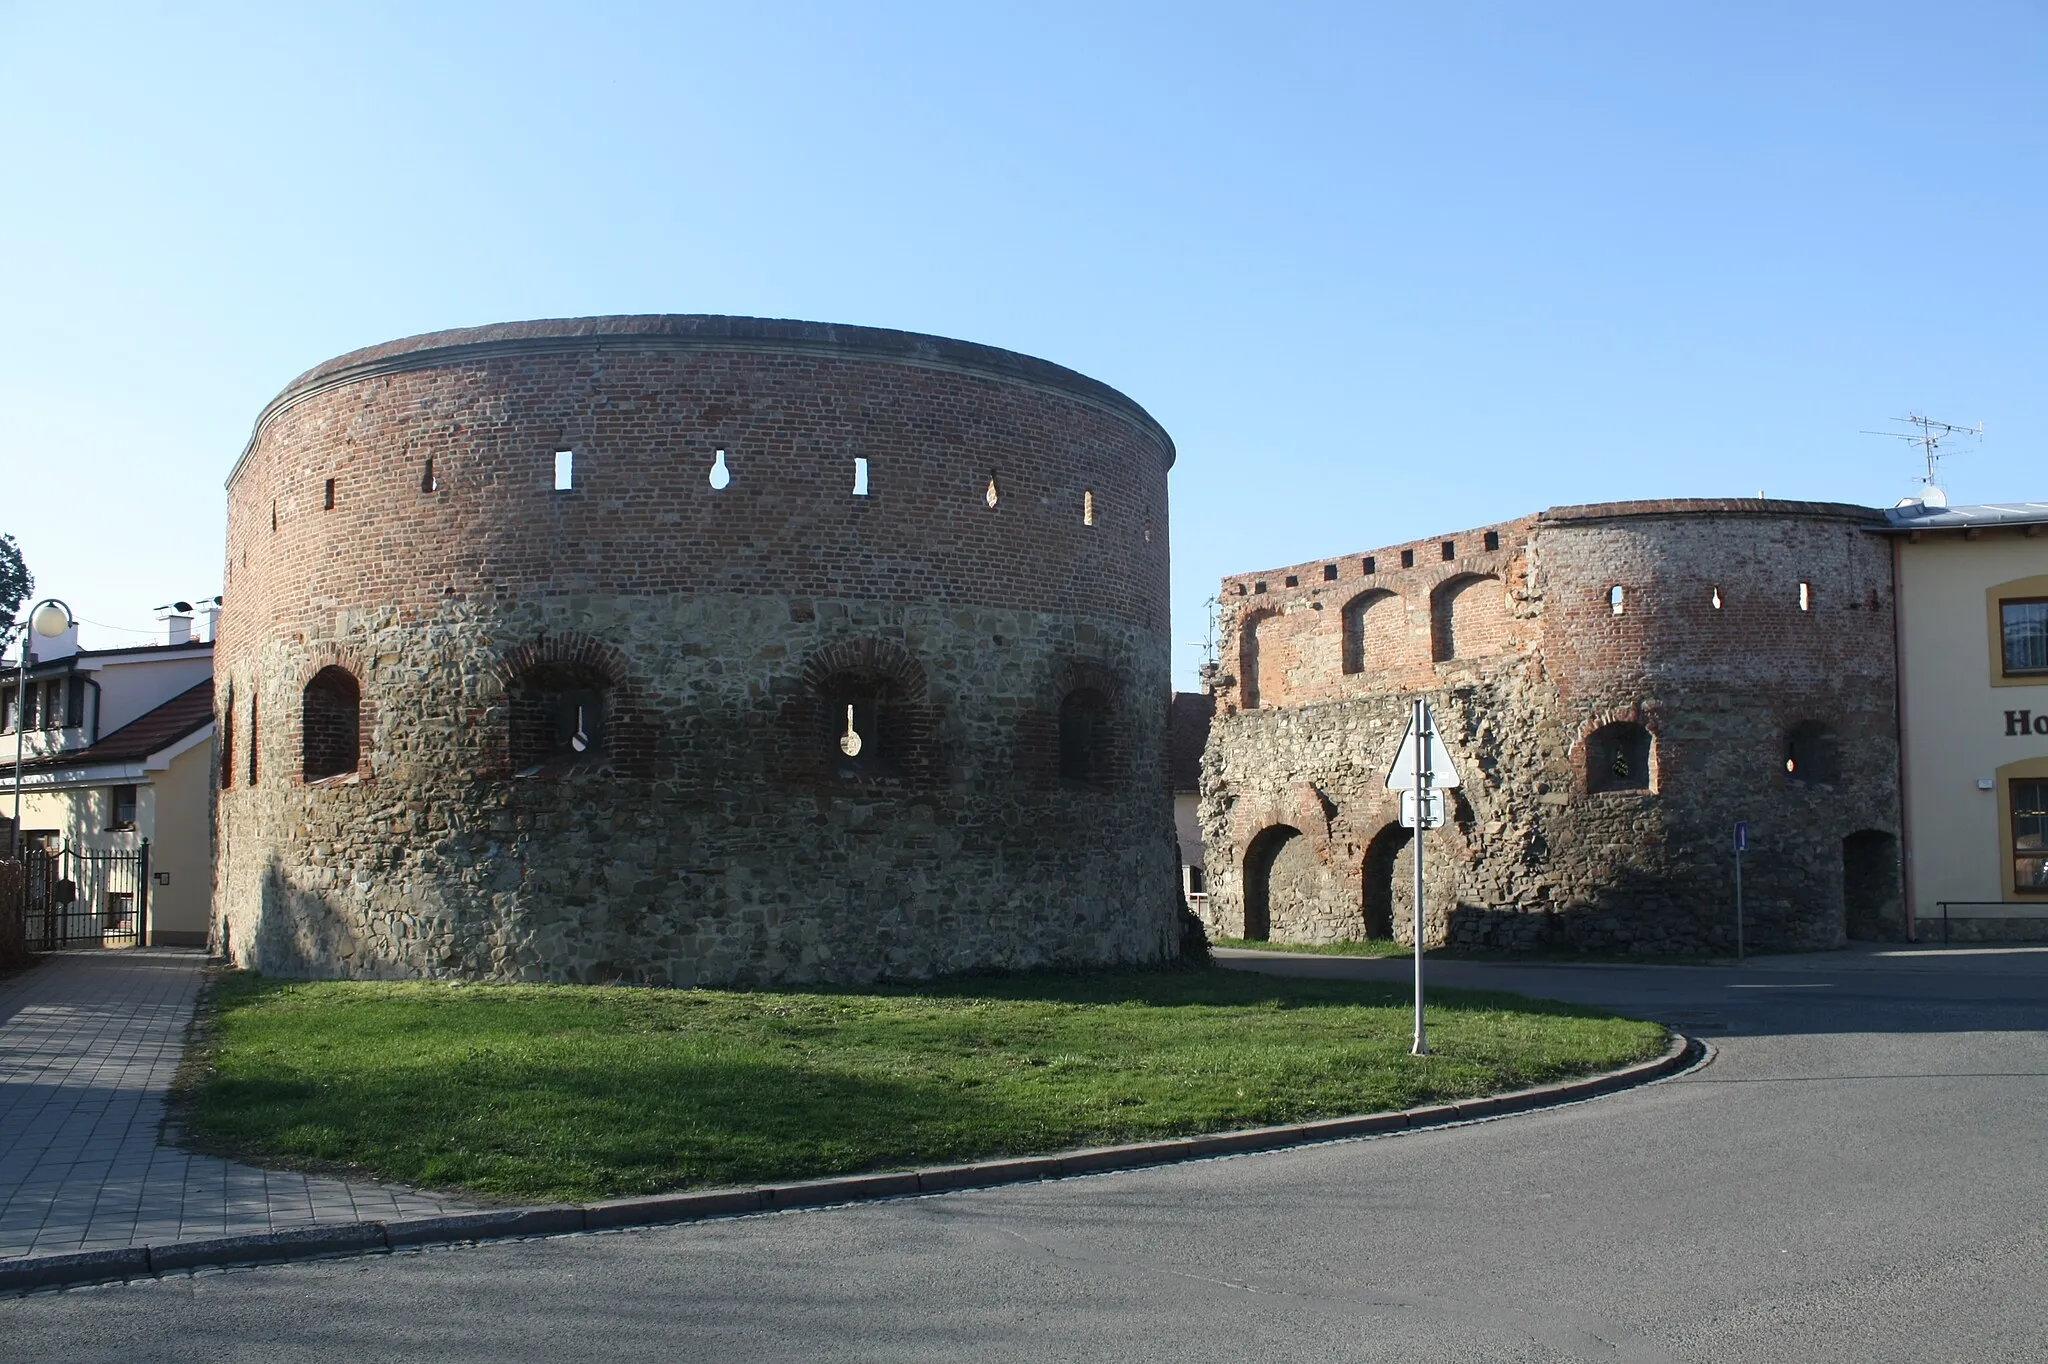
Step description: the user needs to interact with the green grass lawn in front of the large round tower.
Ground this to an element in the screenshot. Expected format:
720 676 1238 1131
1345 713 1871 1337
180 969 1665 1200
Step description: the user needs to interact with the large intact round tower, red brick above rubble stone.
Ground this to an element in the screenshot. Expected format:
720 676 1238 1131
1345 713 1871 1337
215 317 1178 985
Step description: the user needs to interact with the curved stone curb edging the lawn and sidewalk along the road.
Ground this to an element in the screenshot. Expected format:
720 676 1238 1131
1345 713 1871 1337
0 1032 1708 1292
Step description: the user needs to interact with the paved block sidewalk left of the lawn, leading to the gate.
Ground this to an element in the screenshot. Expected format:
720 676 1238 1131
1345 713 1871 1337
0 948 461 1262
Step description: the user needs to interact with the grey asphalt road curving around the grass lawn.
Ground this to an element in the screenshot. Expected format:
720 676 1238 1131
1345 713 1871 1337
0 950 2048 1364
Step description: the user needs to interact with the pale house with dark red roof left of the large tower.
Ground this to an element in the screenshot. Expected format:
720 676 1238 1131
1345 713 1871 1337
0 616 213 946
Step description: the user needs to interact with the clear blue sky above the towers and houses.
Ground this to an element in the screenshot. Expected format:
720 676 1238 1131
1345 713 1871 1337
0 2 2048 686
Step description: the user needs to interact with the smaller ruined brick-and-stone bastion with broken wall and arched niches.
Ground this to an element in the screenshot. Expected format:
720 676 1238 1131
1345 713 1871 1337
1202 500 1903 952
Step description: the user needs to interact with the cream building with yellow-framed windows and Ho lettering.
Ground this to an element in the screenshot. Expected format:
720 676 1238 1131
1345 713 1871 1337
1886 502 2048 942
